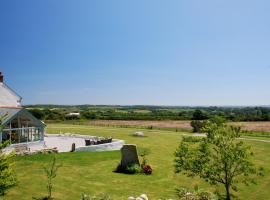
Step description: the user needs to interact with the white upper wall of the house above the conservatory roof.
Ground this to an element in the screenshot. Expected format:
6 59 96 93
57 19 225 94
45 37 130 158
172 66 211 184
0 82 22 107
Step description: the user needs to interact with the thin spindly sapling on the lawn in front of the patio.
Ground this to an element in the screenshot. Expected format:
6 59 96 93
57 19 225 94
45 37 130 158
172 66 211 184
44 156 61 200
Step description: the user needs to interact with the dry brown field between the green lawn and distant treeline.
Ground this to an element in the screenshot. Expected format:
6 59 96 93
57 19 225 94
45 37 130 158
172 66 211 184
80 120 270 132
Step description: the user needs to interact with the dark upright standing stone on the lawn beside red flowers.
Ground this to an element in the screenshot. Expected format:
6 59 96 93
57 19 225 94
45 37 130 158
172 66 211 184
121 144 140 168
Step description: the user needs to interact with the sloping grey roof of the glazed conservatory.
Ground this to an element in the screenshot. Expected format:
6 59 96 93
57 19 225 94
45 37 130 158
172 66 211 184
0 107 45 126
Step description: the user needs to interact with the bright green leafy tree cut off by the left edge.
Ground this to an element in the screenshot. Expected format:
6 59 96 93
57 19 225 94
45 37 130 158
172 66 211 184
0 119 17 196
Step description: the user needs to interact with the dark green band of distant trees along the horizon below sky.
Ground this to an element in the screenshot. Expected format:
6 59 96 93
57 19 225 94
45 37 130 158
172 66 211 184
26 105 270 121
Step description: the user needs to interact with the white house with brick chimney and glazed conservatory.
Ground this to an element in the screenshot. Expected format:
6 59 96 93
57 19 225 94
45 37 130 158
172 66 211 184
0 72 46 144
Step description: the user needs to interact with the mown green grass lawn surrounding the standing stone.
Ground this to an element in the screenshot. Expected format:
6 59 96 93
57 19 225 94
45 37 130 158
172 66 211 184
5 124 270 200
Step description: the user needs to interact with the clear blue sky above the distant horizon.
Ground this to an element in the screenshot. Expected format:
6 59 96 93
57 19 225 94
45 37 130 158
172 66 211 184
0 0 270 105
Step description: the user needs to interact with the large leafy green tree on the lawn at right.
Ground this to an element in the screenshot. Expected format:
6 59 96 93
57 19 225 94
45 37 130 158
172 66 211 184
175 122 259 200
